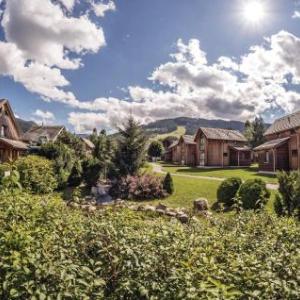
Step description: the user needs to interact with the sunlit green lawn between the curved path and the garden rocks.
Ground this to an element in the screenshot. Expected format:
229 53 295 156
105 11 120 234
141 176 275 211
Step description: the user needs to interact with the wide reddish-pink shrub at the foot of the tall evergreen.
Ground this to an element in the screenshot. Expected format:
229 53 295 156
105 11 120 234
111 174 166 200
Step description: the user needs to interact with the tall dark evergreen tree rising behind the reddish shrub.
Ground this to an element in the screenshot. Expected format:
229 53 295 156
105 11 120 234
115 117 146 176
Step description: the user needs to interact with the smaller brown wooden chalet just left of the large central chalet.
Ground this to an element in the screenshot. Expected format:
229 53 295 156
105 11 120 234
165 135 196 165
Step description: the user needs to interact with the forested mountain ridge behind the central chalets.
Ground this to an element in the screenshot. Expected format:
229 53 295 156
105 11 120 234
143 117 244 135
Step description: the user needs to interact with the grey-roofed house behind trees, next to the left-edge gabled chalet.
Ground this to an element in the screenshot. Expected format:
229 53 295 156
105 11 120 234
22 125 65 146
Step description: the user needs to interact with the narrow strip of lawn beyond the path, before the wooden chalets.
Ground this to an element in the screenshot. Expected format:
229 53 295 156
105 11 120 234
162 163 277 183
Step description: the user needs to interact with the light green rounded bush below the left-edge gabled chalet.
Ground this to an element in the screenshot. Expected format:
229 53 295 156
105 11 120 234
16 155 57 194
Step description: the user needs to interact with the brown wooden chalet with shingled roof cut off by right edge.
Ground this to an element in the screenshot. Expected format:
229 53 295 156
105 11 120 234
254 111 300 173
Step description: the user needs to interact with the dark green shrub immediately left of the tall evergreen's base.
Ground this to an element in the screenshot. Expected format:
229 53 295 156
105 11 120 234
82 158 103 188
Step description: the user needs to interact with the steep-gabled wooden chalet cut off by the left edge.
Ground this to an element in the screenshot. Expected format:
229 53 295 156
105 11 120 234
0 99 28 163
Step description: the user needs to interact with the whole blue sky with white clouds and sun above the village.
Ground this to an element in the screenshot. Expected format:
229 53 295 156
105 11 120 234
0 0 300 133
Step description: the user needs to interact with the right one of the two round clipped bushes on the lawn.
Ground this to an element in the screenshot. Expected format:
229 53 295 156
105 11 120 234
238 179 271 209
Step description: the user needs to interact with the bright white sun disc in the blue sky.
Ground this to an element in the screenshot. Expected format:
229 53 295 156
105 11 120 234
242 0 266 26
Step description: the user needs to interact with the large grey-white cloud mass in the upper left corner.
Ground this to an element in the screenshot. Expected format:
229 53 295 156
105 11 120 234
0 0 105 107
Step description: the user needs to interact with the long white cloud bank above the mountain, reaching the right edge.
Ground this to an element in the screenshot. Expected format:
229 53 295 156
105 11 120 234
69 31 300 131
